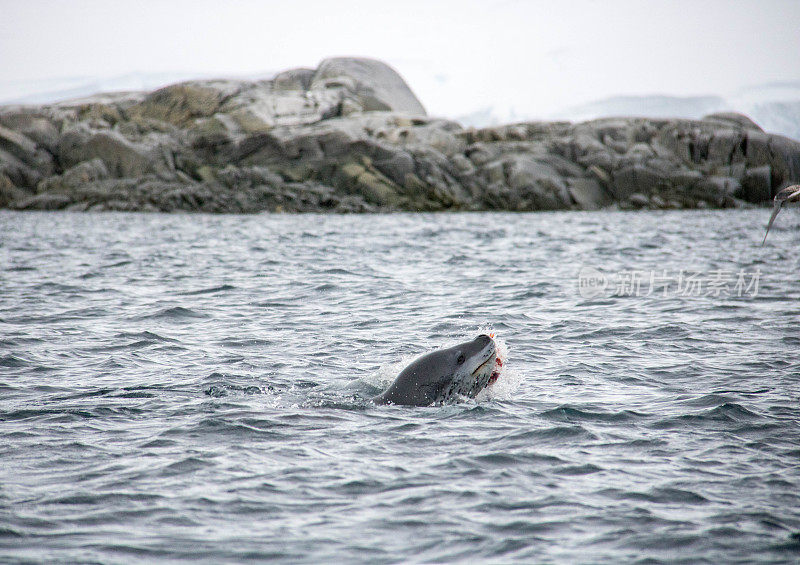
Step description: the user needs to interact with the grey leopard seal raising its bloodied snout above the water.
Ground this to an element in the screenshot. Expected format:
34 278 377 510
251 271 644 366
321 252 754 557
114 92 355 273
372 334 498 406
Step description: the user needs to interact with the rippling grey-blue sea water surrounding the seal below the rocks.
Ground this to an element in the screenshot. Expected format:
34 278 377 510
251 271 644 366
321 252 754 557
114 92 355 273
0 210 800 563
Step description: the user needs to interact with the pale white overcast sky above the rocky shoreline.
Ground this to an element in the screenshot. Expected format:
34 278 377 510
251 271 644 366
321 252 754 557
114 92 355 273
0 0 800 116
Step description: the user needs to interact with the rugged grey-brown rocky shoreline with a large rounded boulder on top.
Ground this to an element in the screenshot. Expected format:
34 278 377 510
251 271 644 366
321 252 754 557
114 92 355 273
0 58 800 213
